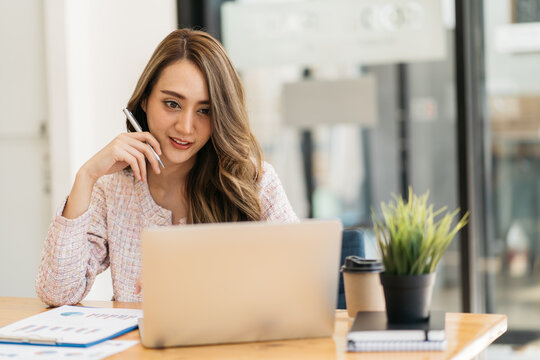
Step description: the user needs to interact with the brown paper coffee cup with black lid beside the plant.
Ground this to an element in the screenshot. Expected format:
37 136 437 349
341 256 385 317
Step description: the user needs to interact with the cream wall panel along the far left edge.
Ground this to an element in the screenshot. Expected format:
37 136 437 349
0 0 50 297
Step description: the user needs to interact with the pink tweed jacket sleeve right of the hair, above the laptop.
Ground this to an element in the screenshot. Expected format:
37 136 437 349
259 162 299 223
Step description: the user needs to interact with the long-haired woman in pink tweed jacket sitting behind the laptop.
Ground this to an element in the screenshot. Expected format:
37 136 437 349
36 29 298 306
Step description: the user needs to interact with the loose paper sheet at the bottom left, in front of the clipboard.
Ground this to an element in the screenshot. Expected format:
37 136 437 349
0 340 138 360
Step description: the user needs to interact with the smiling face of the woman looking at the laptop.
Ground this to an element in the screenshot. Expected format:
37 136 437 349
143 60 212 167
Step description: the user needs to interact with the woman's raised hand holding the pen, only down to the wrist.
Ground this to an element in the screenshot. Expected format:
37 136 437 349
81 132 161 182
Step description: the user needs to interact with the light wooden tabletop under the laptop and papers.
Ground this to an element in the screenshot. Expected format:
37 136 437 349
0 297 507 360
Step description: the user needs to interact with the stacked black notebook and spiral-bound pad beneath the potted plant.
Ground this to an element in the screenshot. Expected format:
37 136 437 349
347 311 446 351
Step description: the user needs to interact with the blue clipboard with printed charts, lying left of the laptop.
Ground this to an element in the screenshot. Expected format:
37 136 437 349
0 305 143 347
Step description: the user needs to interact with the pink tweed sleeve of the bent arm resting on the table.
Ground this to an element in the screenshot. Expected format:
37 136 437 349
36 178 109 306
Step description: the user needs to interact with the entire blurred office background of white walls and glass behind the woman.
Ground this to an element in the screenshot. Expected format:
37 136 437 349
0 0 540 359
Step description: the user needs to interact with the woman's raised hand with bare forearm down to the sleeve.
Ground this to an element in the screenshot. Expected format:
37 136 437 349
62 132 161 219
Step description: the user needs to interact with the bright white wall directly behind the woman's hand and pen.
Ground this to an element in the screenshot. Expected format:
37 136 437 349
45 0 176 299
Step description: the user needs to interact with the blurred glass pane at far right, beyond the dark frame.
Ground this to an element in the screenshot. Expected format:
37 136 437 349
484 0 540 343
